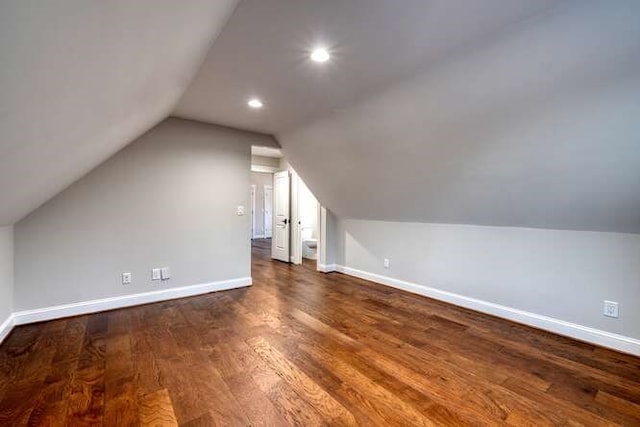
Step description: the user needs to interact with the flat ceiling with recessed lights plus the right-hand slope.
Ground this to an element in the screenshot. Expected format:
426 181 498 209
176 0 640 233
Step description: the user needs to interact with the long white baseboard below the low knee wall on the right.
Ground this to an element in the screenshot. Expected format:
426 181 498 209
336 265 640 356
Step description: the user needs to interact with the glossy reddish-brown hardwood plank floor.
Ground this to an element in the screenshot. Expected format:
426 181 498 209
0 241 640 426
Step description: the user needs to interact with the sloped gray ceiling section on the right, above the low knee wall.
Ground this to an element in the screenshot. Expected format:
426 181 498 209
277 0 640 233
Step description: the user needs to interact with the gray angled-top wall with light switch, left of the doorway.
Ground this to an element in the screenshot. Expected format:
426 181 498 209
14 118 271 310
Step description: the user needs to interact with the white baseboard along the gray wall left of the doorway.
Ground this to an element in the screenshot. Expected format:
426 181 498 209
11 277 252 328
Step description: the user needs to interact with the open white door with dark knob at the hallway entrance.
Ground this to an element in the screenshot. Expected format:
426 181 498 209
271 171 290 262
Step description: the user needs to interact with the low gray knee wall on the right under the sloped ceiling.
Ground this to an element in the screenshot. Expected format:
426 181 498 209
336 220 640 338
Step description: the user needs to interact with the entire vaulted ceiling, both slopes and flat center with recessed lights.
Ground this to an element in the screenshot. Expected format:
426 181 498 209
0 0 640 233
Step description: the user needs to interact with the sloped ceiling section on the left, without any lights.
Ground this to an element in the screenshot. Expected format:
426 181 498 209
0 0 237 225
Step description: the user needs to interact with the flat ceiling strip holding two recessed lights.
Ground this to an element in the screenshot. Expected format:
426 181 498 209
174 0 558 133
